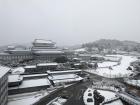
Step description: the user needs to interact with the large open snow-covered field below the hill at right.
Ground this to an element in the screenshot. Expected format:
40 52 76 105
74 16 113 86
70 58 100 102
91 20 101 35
87 55 137 78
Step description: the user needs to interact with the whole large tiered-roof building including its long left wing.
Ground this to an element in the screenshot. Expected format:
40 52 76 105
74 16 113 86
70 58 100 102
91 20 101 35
0 39 66 63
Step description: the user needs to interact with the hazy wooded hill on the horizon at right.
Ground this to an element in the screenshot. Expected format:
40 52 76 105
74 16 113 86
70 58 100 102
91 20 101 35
82 39 140 52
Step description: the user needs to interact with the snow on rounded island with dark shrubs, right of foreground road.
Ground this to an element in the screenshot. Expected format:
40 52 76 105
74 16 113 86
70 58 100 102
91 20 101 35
83 88 123 105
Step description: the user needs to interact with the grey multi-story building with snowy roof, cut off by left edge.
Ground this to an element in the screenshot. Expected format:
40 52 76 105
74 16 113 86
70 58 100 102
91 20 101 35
0 66 10 105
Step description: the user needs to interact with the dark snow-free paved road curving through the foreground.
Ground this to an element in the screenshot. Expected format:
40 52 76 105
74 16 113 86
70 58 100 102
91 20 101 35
34 81 92 105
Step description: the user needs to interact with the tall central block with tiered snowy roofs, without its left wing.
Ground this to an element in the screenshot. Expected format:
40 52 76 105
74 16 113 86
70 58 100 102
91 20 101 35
32 39 65 61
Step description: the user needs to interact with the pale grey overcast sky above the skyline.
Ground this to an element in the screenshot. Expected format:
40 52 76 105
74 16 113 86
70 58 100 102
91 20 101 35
0 0 140 45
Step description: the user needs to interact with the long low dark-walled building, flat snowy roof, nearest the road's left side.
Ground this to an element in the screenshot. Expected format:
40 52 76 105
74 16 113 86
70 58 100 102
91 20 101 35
8 78 51 95
